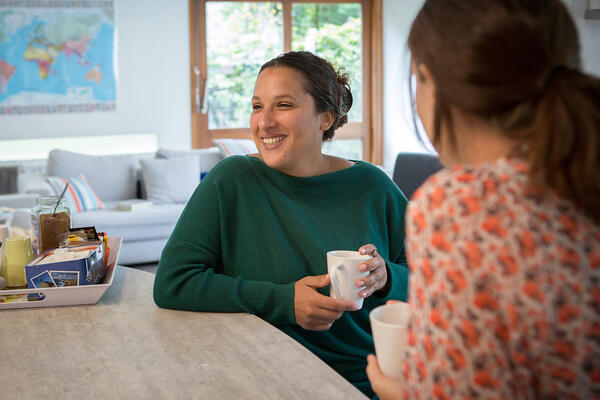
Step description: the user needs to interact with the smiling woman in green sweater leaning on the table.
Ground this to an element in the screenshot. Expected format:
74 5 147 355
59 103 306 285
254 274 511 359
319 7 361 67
154 52 408 396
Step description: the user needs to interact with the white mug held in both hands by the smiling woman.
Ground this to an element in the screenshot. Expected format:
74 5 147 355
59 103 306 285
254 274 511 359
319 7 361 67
327 250 373 309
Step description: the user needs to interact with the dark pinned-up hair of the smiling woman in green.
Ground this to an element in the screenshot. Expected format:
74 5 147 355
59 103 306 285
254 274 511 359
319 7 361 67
258 51 352 142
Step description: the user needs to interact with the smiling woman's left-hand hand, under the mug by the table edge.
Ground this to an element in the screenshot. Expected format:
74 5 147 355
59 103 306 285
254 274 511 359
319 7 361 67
294 274 358 331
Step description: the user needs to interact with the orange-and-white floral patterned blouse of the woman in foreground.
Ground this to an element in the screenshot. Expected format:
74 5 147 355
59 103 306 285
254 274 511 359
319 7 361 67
403 159 600 399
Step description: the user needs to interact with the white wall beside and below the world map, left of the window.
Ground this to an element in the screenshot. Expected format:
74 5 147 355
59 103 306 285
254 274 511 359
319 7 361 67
0 0 191 153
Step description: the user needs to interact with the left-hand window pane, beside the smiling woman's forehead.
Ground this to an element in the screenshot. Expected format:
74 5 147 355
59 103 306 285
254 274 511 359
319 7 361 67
206 2 283 129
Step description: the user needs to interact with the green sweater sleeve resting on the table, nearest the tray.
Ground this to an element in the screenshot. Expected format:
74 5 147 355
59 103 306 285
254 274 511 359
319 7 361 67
154 162 295 323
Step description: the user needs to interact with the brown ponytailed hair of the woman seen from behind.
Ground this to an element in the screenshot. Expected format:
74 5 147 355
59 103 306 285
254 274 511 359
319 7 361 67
408 0 600 223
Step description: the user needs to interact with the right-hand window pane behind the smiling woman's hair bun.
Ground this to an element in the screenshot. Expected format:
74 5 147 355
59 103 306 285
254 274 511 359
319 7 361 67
292 3 362 121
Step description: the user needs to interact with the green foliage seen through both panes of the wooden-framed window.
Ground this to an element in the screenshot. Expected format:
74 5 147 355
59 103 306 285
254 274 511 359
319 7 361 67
206 2 362 129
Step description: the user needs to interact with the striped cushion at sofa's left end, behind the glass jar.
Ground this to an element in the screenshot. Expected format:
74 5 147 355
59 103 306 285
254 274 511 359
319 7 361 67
46 174 104 212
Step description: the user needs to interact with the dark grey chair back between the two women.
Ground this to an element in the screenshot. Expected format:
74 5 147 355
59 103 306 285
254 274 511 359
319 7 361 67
393 153 443 199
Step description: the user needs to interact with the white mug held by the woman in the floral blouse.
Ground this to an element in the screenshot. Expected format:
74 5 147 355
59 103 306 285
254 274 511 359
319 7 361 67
369 302 410 379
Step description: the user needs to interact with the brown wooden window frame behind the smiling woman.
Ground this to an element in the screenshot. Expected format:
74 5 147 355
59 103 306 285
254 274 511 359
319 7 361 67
188 0 383 164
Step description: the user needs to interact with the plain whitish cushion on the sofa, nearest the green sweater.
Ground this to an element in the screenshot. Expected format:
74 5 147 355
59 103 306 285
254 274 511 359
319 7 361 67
140 156 200 204
